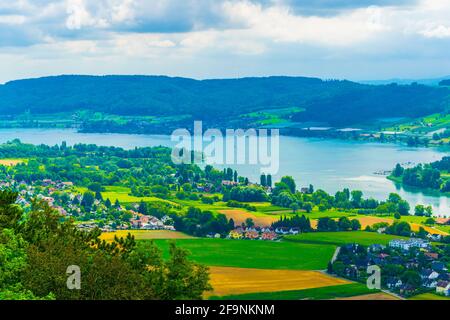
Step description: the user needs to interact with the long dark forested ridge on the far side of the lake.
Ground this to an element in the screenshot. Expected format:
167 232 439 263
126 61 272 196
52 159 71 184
0 75 450 126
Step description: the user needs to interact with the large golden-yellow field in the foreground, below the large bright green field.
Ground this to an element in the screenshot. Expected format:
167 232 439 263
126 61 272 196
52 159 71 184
206 267 351 297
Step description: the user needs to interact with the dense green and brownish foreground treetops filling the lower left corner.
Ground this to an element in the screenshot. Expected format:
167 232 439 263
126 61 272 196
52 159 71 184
0 191 211 300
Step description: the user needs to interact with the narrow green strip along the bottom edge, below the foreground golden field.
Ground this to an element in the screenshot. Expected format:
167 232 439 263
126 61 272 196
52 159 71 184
210 283 379 300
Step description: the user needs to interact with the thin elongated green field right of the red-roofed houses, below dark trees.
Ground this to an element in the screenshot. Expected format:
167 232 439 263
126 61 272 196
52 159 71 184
284 231 408 246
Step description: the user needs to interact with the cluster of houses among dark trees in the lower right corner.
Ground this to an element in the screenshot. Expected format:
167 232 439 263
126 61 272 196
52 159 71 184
328 238 450 297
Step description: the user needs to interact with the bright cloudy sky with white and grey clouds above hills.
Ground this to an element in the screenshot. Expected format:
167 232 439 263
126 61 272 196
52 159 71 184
0 0 450 82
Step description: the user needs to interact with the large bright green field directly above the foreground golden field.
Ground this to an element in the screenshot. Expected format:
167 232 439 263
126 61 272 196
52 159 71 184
146 239 335 270
